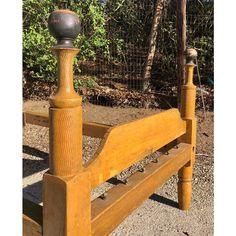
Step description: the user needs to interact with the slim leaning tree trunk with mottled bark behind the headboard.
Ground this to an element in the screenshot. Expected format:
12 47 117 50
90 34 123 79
143 0 166 90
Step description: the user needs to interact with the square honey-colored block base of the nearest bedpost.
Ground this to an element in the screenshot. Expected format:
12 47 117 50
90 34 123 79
43 172 91 236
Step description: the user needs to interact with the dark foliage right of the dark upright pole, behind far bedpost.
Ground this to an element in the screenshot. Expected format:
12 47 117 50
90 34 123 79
187 0 214 82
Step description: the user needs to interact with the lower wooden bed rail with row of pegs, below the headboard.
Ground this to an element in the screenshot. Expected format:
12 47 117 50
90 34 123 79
92 143 191 236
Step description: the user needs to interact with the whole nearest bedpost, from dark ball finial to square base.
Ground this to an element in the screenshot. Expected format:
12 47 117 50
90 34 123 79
43 10 91 236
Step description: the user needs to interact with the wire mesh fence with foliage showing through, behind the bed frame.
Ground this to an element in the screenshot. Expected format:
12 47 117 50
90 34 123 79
23 0 214 109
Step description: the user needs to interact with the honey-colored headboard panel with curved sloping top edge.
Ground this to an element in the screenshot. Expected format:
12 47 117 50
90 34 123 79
87 109 186 188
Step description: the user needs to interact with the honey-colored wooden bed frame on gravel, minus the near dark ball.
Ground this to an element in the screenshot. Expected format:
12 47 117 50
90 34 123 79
23 8 196 236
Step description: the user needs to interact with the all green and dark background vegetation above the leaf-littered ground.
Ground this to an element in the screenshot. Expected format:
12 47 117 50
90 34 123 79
23 0 213 87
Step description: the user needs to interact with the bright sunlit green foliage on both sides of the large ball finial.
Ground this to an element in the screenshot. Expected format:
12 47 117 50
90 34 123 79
23 0 109 81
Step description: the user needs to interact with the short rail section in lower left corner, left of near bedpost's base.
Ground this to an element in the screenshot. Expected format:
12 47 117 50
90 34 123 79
23 199 43 236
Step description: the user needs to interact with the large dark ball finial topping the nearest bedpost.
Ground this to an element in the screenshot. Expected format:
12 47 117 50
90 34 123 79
48 9 81 48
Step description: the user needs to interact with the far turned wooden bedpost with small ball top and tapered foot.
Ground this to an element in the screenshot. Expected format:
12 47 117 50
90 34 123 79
178 49 197 210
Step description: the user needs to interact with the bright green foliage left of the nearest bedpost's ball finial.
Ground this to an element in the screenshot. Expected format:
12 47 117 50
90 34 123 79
23 0 56 80
